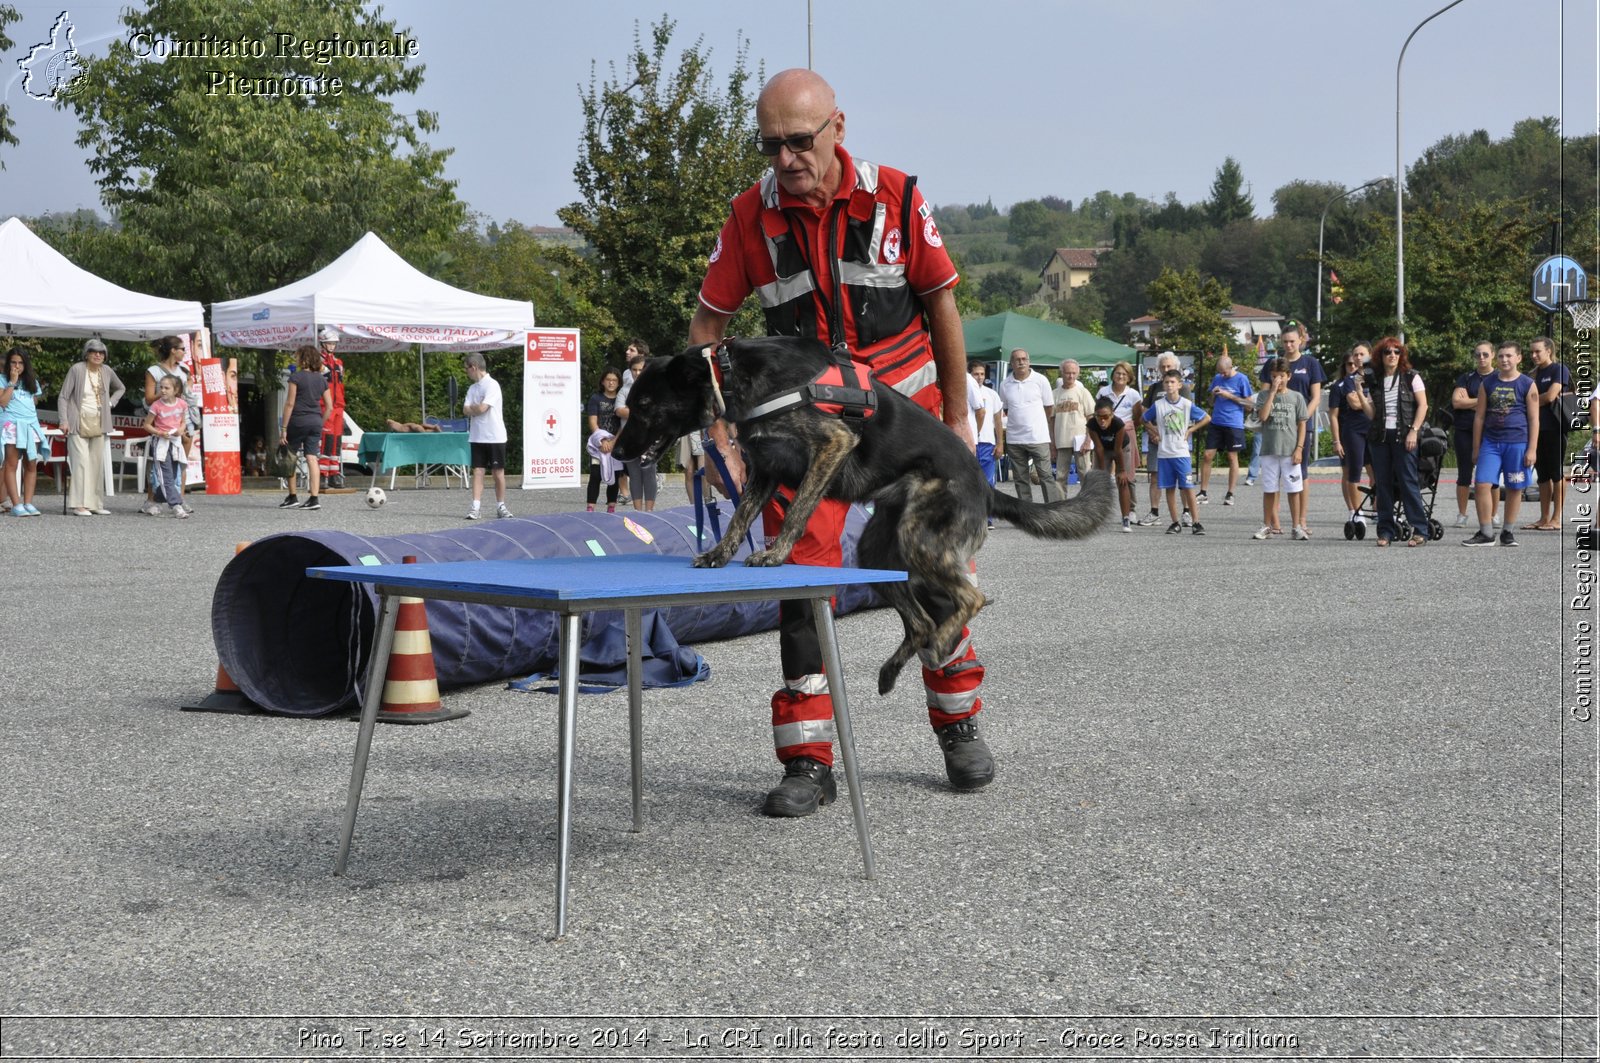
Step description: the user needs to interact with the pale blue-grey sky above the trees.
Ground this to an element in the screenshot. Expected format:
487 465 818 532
0 0 1600 224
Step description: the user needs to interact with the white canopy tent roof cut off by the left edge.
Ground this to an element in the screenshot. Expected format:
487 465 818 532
0 218 205 339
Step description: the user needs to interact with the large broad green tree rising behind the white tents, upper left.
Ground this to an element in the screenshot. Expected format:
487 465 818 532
58 0 462 303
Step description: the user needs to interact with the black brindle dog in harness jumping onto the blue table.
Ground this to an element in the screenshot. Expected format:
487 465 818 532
611 336 1112 693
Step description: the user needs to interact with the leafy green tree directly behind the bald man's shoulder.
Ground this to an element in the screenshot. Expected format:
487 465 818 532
557 16 766 377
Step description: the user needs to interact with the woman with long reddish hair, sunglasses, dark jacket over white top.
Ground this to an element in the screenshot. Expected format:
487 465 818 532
1349 336 1429 546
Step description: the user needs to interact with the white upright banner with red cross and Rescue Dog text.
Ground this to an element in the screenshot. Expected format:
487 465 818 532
522 328 584 490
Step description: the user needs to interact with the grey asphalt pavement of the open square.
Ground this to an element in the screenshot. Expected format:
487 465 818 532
0 479 1600 1058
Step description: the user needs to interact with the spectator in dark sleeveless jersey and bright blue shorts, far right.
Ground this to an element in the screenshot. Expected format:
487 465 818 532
1461 343 1539 546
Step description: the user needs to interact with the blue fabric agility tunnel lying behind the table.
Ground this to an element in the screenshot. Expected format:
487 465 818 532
211 506 878 716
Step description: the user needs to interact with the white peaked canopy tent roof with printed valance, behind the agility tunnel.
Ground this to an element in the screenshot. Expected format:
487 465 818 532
211 232 533 354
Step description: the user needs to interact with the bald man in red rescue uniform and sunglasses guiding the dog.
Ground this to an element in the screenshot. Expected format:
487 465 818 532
690 70 995 816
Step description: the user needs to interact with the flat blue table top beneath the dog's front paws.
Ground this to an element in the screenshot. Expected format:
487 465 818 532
307 554 907 604
